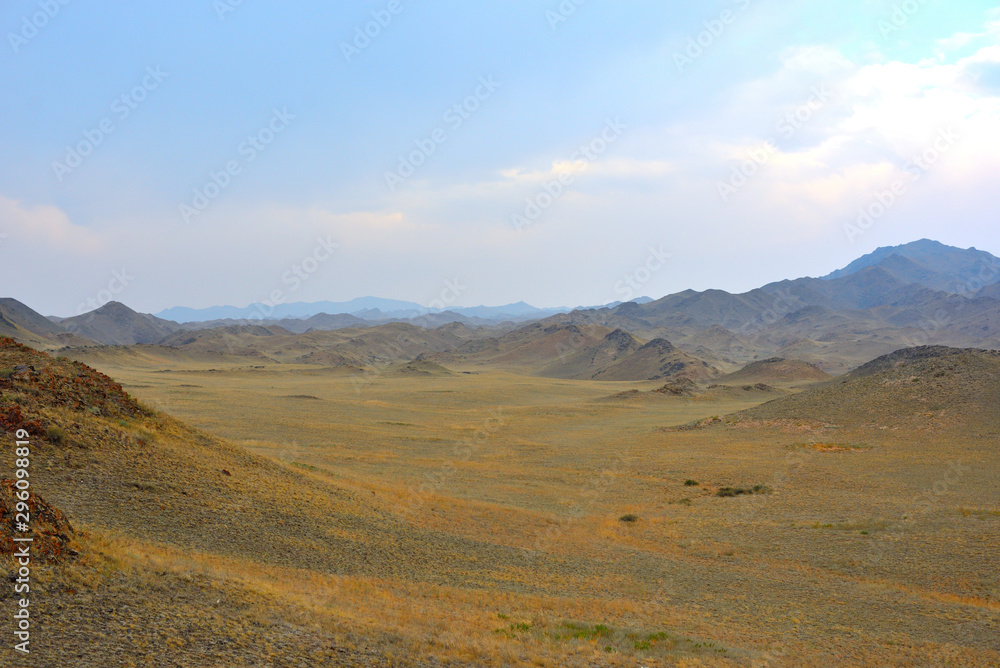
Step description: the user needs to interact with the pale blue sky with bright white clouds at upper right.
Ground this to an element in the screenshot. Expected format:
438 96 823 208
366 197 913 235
0 0 1000 316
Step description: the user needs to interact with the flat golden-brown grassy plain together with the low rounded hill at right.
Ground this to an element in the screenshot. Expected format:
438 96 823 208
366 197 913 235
29 346 1000 666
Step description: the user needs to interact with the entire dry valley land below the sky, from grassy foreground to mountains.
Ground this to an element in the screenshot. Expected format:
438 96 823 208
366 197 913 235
0 239 1000 667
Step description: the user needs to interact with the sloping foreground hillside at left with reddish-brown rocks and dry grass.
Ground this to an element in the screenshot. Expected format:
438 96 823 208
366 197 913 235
0 339 584 667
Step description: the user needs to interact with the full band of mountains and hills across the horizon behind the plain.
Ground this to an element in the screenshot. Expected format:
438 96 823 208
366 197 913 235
0 239 1000 380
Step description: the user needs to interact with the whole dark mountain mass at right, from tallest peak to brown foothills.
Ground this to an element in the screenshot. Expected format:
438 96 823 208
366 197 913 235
508 241 1000 373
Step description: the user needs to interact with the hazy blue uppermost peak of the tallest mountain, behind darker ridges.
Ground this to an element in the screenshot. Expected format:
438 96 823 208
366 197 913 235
823 239 1000 293
